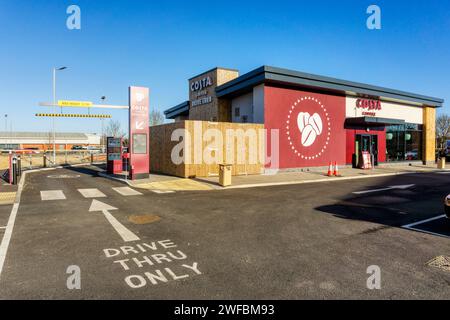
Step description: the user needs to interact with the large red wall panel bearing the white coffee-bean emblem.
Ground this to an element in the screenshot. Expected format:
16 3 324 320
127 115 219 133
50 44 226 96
264 86 346 168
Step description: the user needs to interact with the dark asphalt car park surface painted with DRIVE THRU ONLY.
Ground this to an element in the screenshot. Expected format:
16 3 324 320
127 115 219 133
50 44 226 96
0 168 450 299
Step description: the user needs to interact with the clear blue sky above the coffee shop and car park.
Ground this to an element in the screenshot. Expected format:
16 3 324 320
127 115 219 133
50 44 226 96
0 0 450 132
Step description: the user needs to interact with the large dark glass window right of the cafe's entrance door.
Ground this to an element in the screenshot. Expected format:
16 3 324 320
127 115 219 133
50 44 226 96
386 123 422 162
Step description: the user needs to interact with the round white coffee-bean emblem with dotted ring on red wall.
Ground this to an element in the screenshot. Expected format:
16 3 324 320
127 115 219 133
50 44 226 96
286 96 331 160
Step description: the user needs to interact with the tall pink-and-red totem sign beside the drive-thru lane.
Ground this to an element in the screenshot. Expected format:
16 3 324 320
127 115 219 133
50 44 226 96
128 87 150 179
